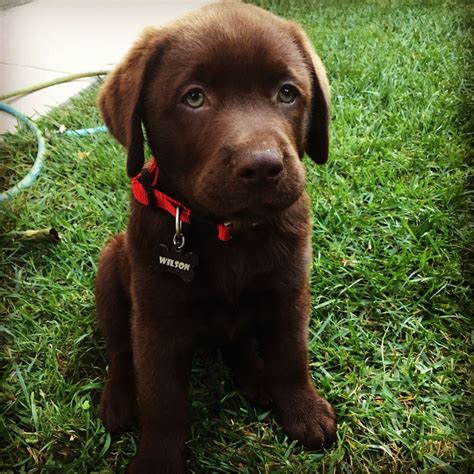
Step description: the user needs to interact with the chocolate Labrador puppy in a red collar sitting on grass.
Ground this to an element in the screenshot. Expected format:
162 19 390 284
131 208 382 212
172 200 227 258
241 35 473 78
96 2 336 473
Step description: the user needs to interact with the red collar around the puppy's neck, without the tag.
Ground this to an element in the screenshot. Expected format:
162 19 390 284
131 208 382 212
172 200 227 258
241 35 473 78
132 159 232 242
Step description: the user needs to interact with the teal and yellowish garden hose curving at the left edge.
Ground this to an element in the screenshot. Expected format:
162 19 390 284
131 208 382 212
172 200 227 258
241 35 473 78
0 71 108 204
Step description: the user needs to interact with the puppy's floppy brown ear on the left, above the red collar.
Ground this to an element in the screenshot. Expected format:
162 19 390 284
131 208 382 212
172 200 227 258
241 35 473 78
99 28 166 177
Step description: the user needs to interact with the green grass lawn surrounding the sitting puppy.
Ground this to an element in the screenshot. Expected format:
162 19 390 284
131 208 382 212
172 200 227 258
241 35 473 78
0 0 474 473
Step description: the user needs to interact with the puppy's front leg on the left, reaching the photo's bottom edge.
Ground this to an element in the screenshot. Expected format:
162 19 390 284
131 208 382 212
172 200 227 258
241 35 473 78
127 312 194 474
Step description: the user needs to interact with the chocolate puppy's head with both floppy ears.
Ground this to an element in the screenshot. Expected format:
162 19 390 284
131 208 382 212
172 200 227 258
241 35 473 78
99 2 329 220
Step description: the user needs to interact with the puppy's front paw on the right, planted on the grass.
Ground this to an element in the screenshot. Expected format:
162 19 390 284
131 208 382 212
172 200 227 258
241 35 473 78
278 389 337 451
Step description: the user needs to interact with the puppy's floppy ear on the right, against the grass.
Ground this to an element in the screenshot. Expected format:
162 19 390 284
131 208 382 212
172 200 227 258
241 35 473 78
290 22 330 164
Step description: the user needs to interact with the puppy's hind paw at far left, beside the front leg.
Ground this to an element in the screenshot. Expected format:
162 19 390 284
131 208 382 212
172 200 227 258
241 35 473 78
99 380 138 433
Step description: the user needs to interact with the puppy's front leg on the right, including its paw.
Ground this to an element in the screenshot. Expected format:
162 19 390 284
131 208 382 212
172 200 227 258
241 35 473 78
262 288 336 450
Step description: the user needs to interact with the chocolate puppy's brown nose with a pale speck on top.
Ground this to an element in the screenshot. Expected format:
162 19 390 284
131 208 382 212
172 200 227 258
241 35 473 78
234 150 283 185
